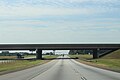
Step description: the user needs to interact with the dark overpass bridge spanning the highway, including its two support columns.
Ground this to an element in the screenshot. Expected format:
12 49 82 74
0 44 120 59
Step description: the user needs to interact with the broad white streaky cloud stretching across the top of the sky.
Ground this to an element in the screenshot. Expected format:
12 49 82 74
0 0 120 18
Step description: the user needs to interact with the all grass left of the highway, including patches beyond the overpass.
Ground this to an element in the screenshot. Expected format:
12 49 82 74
0 56 57 74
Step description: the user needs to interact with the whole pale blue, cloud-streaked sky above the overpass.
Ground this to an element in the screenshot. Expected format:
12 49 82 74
0 0 120 44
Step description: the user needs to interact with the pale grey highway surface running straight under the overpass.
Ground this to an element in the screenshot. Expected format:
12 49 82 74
0 56 120 80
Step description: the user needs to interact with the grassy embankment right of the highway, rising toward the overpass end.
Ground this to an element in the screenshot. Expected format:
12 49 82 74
70 50 120 72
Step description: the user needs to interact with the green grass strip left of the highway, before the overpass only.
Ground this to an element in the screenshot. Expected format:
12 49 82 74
0 60 47 73
